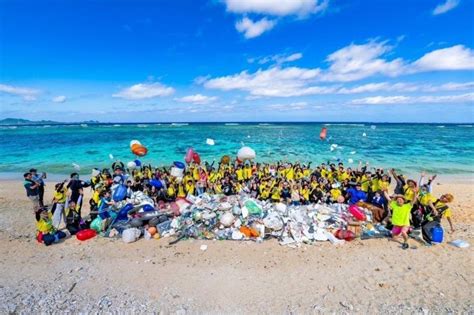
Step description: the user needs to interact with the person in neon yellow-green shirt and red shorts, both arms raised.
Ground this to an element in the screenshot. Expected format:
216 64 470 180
384 187 418 249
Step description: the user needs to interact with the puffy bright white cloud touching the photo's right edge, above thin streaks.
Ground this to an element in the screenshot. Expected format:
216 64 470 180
411 45 474 72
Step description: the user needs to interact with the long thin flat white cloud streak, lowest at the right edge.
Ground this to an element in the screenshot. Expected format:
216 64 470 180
350 93 474 105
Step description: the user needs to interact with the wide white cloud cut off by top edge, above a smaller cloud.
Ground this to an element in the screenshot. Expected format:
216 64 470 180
225 0 329 17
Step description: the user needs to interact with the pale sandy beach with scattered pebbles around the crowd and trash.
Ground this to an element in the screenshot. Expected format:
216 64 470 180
0 177 474 314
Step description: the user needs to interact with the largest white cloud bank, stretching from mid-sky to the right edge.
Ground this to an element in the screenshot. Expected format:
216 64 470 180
199 41 474 99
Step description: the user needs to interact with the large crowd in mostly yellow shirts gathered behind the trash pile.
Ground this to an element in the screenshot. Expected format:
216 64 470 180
24 161 454 248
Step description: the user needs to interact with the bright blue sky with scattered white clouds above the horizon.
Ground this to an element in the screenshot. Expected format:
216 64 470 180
0 0 474 123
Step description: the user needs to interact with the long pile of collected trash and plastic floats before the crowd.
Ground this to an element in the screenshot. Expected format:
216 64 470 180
84 191 390 247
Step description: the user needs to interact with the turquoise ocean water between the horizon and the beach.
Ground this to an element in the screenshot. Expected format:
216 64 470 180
0 123 474 175
